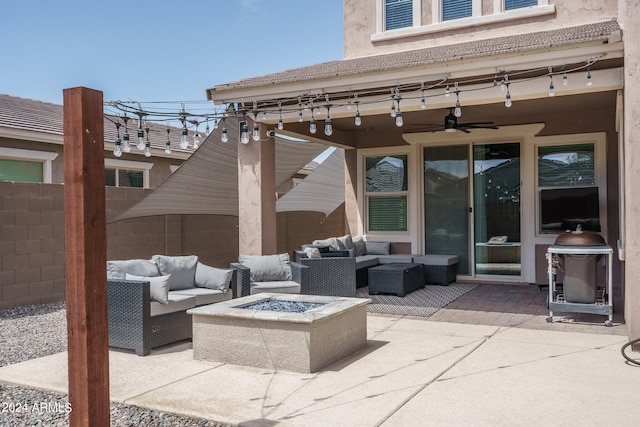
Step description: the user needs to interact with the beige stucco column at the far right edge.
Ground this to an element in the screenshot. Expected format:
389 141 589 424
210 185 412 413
614 0 640 351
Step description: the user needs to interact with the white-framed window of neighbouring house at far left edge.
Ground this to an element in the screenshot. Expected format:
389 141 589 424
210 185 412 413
0 147 58 184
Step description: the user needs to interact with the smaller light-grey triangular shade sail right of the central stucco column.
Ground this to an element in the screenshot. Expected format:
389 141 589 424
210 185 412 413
276 149 344 216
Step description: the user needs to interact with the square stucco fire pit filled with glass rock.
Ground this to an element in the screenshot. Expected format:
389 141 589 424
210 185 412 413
188 293 371 372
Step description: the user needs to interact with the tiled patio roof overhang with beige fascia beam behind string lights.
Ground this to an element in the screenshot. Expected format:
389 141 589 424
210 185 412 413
207 21 623 148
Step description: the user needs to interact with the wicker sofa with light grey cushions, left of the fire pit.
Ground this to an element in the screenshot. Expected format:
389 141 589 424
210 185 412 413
107 255 237 356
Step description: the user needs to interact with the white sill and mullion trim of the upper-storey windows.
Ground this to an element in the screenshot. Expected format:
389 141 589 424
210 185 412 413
371 0 556 42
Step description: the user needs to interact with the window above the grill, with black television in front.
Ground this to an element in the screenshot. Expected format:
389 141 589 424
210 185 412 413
538 143 601 233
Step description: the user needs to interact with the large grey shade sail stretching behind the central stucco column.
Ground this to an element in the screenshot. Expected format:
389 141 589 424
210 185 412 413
108 119 326 222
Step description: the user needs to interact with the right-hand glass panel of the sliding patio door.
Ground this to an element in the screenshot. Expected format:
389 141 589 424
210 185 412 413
473 143 521 276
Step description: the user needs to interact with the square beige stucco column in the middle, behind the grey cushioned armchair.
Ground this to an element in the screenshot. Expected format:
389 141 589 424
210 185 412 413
237 121 277 255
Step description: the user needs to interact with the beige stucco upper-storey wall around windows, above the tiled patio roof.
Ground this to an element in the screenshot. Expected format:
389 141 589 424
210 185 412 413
344 0 618 58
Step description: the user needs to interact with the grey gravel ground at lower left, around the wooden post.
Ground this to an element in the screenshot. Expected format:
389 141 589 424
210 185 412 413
0 303 229 427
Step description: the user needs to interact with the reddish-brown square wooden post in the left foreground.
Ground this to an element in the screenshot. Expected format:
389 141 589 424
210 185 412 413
63 87 109 426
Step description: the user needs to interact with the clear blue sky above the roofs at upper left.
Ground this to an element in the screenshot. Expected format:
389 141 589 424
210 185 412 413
0 0 343 104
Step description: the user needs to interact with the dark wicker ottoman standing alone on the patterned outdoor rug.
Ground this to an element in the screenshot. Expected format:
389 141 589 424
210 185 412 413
369 263 424 297
